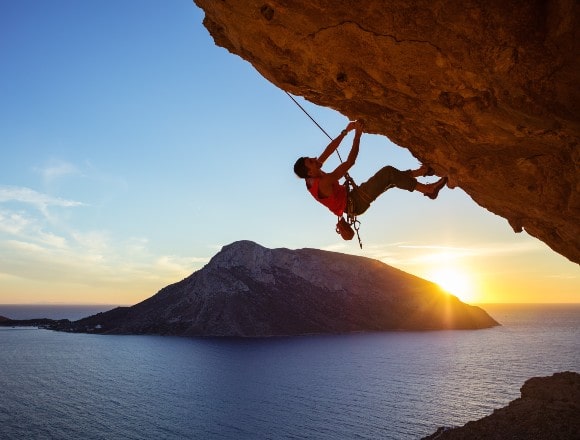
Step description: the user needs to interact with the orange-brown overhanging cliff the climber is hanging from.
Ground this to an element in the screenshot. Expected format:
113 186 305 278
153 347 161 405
195 0 580 262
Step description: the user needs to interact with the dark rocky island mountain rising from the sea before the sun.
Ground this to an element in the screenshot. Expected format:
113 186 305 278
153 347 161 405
60 241 498 337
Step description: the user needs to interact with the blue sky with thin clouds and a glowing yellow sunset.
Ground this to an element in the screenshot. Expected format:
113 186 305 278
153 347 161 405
0 0 580 305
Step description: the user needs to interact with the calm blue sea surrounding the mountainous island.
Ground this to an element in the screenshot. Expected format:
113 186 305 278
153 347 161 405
0 305 580 440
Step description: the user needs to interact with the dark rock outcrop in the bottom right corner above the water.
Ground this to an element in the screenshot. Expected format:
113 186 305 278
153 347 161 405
424 372 580 440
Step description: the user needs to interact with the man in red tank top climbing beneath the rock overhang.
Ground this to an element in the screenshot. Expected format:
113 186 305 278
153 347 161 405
294 121 447 217
